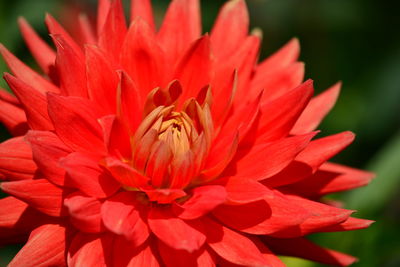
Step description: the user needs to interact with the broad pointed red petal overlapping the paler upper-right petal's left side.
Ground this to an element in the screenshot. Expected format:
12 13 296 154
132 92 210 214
253 80 314 142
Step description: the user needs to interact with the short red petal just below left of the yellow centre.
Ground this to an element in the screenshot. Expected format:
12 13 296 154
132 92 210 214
104 157 149 188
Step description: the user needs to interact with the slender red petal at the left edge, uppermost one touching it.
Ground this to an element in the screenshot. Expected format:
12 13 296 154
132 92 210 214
0 44 59 93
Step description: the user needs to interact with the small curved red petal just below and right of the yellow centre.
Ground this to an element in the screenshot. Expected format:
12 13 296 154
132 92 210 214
172 185 226 220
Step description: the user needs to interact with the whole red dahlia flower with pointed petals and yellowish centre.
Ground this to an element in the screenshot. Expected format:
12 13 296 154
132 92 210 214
0 0 372 267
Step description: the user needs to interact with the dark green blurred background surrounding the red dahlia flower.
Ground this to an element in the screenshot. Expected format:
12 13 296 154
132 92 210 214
0 0 400 267
